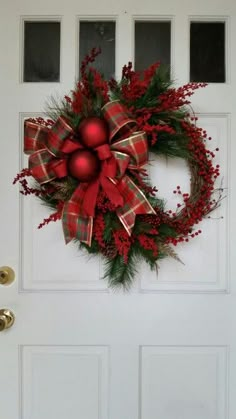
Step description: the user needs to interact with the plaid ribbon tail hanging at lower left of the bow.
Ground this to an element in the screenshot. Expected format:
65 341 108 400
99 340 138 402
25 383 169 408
62 185 93 246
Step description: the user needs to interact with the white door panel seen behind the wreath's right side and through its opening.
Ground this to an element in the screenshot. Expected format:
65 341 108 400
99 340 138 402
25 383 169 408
141 113 230 293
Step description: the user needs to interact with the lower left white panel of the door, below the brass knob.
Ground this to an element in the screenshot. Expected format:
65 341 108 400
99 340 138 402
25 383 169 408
19 345 108 419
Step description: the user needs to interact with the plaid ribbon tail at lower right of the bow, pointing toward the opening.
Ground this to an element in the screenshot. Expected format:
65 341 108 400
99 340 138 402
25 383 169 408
116 176 156 236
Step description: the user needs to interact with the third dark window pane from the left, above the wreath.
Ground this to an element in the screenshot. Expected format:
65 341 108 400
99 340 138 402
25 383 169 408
135 22 171 71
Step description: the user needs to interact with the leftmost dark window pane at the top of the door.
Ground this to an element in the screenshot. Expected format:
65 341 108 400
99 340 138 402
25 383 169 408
23 22 60 82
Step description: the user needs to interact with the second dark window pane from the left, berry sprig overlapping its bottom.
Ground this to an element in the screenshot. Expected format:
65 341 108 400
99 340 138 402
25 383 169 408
79 21 116 78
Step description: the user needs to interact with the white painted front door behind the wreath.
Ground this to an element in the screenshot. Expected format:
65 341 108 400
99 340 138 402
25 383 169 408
0 0 236 419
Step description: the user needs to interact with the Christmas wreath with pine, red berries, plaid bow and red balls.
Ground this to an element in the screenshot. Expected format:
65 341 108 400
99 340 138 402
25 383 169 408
14 49 221 288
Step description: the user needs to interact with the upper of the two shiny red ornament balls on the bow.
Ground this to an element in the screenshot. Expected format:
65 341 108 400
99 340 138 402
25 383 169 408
79 116 109 148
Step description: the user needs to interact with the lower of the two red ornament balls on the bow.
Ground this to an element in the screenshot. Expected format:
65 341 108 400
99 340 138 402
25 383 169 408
68 150 100 182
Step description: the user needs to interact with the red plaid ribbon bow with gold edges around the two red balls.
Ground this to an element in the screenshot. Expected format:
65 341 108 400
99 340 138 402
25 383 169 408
24 101 155 246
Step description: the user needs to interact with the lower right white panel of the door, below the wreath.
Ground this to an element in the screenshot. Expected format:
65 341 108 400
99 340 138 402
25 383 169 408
140 346 228 419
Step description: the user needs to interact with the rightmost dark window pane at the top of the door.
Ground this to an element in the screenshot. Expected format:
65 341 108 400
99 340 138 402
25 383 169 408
190 22 225 83
